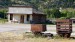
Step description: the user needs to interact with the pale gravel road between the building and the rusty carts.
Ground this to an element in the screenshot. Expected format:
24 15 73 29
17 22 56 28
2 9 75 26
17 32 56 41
0 24 75 36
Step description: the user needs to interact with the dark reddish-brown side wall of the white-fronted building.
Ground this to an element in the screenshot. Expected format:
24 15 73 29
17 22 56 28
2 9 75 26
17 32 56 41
32 14 46 24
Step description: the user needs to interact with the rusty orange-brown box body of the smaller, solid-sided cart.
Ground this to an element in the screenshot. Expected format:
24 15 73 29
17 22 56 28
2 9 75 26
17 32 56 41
31 24 46 32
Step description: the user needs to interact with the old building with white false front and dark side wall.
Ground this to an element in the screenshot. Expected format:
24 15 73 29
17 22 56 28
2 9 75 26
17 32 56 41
8 6 46 24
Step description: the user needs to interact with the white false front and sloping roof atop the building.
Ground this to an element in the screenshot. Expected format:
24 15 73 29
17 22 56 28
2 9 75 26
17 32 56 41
7 6 44 14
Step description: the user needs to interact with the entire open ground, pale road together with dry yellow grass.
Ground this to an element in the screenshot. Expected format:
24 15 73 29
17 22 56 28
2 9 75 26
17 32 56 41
0 24 75 42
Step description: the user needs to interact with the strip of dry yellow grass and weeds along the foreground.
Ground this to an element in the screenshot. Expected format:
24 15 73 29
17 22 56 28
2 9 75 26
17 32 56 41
0 32 75 42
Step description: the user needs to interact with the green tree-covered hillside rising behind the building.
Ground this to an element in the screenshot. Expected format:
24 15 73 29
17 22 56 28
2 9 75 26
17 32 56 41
0 0 75 18
